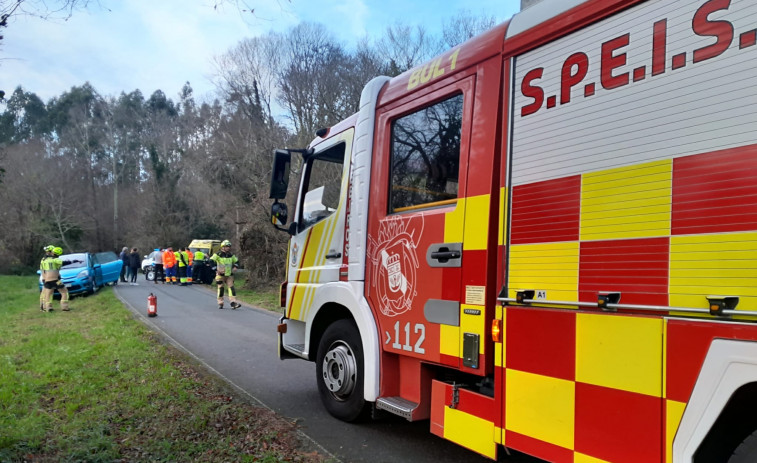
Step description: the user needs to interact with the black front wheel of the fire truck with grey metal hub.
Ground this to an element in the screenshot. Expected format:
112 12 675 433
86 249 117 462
316 320 366 421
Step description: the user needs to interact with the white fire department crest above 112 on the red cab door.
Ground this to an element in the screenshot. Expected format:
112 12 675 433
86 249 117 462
368 216 423 317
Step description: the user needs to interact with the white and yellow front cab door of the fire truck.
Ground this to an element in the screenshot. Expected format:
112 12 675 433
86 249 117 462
287 128 354 321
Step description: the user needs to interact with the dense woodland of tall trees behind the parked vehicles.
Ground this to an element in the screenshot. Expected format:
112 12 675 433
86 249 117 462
0 12 495 285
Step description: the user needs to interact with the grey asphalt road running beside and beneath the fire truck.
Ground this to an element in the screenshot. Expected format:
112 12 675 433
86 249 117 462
114 280 541 463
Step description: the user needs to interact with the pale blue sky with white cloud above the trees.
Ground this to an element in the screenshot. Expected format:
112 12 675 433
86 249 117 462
0 0 520 101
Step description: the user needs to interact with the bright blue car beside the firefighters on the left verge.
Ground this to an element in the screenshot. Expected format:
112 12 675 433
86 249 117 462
37 251 123 295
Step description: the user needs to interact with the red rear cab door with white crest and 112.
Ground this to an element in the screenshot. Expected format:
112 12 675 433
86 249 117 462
366 76 475 367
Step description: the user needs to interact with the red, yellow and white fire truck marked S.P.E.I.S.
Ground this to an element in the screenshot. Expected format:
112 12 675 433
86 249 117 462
271 0 757 463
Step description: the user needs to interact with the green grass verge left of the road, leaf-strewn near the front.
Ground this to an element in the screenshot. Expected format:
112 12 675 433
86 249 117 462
0 276 323 462
